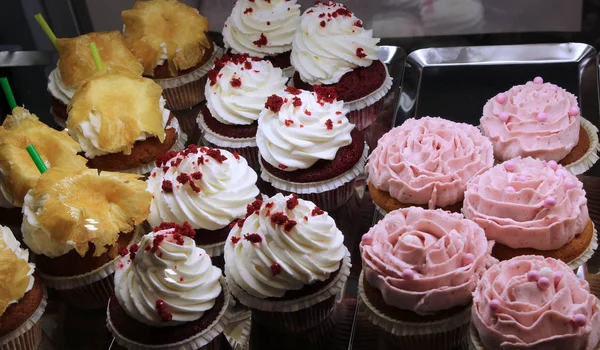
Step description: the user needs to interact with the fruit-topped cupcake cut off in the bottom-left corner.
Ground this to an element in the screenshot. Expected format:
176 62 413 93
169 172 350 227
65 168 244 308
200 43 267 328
0 226 46 350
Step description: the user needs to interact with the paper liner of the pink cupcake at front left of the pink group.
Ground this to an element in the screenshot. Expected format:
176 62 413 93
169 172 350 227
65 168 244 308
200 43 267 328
358 272 471 340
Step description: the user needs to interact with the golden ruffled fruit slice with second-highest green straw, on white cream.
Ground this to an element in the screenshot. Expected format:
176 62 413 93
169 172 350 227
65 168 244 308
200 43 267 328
67 71 165 154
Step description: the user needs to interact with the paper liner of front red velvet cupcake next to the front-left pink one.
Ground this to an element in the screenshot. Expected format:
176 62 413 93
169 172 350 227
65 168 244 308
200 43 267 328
225 249 352 312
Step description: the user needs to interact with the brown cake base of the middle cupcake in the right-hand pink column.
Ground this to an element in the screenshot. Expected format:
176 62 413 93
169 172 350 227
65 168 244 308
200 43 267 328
492 219 598 269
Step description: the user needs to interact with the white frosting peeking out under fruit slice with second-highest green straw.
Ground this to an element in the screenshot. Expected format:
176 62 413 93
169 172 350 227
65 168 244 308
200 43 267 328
69 96 171 159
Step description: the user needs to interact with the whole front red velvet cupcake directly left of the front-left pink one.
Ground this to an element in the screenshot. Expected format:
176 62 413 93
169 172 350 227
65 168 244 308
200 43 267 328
225 193 350 332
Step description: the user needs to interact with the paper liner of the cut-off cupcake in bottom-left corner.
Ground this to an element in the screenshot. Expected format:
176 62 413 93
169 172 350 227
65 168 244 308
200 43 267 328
0 288 48 350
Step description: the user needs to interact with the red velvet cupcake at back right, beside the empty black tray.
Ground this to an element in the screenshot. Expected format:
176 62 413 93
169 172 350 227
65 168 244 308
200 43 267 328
291 1 392 130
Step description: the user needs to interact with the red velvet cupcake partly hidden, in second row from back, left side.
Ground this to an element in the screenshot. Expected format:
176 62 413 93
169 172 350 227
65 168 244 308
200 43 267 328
198 54 287 171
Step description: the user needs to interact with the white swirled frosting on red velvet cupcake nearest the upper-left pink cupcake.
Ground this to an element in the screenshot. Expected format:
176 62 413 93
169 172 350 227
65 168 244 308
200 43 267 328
256 88 354 171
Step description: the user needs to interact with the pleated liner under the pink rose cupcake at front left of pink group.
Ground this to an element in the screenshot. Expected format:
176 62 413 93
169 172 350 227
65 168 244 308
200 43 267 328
358 272 471 336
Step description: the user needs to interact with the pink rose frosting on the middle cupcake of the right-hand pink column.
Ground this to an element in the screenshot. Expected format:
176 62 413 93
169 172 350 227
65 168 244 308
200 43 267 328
462 157 589 250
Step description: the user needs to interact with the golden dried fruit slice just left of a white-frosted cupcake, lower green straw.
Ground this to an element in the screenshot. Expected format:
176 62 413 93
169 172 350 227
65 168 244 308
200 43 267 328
22 169 152 257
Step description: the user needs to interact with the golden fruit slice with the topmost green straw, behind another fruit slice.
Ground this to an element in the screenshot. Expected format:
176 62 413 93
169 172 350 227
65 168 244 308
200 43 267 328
56 31 144 89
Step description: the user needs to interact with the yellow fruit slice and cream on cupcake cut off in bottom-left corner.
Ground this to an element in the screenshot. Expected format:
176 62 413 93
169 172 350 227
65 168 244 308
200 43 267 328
0 226 34 315
